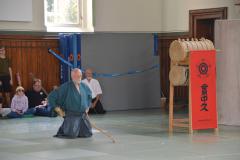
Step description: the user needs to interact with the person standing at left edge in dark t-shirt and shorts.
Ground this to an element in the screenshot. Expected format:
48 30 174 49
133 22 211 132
0 46 13 106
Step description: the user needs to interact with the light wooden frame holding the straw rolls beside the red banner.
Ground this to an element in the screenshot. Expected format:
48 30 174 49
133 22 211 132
169 39 218 134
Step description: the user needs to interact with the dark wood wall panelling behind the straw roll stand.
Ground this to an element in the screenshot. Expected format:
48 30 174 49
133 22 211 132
158 34 188 103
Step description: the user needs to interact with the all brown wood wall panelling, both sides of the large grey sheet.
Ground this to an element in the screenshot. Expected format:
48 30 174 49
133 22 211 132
0 34 188 103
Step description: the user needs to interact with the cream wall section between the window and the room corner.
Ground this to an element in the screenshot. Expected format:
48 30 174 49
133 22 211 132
94 0 162 32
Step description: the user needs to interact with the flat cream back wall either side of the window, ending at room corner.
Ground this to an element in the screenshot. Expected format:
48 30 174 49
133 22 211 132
0 0 162 32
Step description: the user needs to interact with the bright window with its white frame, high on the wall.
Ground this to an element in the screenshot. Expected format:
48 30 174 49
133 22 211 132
44 0 94 32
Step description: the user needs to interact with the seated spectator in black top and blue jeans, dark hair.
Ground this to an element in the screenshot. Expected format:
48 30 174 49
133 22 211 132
26 79 57 117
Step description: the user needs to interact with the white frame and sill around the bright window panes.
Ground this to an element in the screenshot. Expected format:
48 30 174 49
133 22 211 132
44 0 94 32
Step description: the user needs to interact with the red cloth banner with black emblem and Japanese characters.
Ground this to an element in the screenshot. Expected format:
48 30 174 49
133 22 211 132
190 50 217 130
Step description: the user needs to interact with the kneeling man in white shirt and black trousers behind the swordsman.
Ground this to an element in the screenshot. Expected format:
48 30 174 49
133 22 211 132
82 69 106 114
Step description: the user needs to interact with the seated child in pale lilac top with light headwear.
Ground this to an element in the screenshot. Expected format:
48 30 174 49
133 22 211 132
7 86 35 118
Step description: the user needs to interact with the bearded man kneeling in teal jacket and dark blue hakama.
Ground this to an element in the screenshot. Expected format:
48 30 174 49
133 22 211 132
48 68 92 138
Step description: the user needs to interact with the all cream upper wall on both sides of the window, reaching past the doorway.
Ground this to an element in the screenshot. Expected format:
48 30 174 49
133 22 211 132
0 0 240 32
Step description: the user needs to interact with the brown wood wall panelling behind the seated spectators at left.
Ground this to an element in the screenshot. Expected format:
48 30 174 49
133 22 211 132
0 35 60 92
